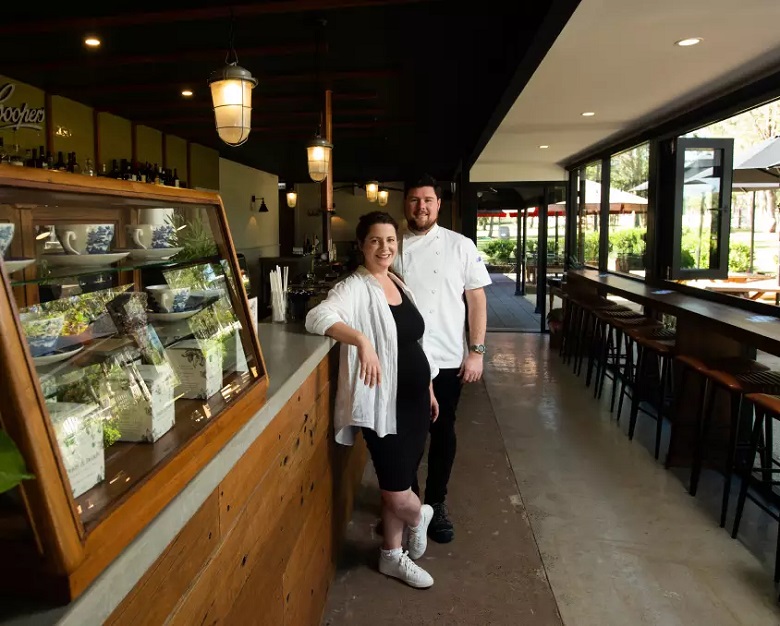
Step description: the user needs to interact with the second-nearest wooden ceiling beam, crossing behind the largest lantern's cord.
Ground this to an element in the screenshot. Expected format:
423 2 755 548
6 43 316 72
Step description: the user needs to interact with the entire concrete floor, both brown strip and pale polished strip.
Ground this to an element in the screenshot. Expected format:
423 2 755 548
323 333 780 626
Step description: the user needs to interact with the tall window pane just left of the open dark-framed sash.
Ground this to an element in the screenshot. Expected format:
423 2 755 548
608 143 650 276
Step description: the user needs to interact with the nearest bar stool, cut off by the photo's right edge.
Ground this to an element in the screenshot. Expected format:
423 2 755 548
731 393 780 582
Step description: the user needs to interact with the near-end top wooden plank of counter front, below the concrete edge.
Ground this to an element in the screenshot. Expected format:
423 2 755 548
106 490 219 626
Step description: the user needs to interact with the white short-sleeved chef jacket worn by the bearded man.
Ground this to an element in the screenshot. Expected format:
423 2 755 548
393 224 492 369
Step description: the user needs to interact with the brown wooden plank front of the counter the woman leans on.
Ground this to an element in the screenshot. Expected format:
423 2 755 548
108 348 367 626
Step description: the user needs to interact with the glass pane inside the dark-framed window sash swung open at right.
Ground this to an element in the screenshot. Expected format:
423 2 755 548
680 148 723 269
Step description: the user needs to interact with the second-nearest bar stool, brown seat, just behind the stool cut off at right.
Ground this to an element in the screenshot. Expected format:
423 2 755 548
678 356 780 528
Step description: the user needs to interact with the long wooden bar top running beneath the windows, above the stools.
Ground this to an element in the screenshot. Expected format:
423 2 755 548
567 270 780 356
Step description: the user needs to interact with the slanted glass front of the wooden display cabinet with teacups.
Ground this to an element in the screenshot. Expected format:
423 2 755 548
0 188 262 527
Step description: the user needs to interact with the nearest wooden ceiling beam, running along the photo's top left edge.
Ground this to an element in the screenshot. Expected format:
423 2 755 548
0 0 438 35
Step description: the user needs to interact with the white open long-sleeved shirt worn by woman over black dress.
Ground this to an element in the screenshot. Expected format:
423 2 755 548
306 265 439 445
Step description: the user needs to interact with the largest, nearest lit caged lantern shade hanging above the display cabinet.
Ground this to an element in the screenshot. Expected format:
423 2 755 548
209 65 257 146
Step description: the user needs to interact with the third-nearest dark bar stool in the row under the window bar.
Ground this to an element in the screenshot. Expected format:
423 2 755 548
625 325 676 460
